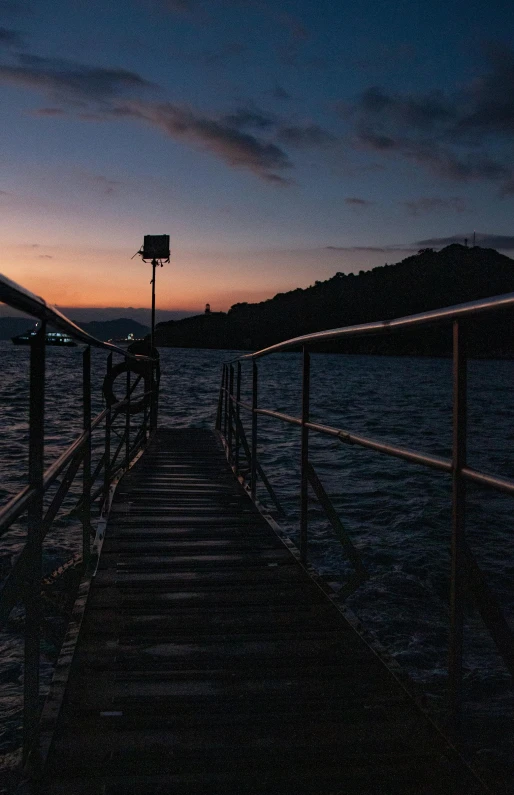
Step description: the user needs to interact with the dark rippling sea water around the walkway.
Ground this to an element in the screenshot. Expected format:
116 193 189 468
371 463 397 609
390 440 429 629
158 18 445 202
0 343 514 772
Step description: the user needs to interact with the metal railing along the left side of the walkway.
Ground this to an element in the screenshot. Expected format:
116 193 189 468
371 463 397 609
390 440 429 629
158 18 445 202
0 275 159 761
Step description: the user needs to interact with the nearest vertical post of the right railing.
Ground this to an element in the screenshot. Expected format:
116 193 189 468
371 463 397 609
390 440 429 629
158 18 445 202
448 320 467 728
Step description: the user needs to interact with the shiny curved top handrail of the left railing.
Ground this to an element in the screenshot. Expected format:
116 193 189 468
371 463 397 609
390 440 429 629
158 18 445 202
0 273 153 361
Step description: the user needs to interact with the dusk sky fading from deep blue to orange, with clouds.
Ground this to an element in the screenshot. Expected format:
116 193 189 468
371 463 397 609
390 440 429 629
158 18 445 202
0 0 514 318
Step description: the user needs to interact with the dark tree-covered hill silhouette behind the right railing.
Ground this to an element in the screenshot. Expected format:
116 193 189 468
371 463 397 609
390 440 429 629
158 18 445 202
156 244 514 356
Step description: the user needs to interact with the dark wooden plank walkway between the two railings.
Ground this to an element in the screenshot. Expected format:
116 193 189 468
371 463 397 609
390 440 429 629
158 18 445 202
41 430 485 795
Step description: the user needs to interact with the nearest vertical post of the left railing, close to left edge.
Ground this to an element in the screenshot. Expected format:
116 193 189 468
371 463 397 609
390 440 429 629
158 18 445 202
23 322 46 762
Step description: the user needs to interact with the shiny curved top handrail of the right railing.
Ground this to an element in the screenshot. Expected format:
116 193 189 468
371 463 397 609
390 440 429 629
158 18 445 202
230 293 514 362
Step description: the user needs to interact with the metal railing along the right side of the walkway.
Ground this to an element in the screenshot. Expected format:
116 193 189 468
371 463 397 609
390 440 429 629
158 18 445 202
216 293 514 727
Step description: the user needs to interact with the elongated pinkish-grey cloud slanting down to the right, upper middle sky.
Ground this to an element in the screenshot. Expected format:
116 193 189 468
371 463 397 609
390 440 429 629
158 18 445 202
116 102 292 184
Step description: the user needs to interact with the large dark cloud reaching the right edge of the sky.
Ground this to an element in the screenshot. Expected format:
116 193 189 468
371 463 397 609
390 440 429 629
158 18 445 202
339 45 514 196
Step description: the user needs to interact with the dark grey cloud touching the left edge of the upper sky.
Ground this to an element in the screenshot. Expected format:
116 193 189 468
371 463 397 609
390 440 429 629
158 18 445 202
0 53 155 104
